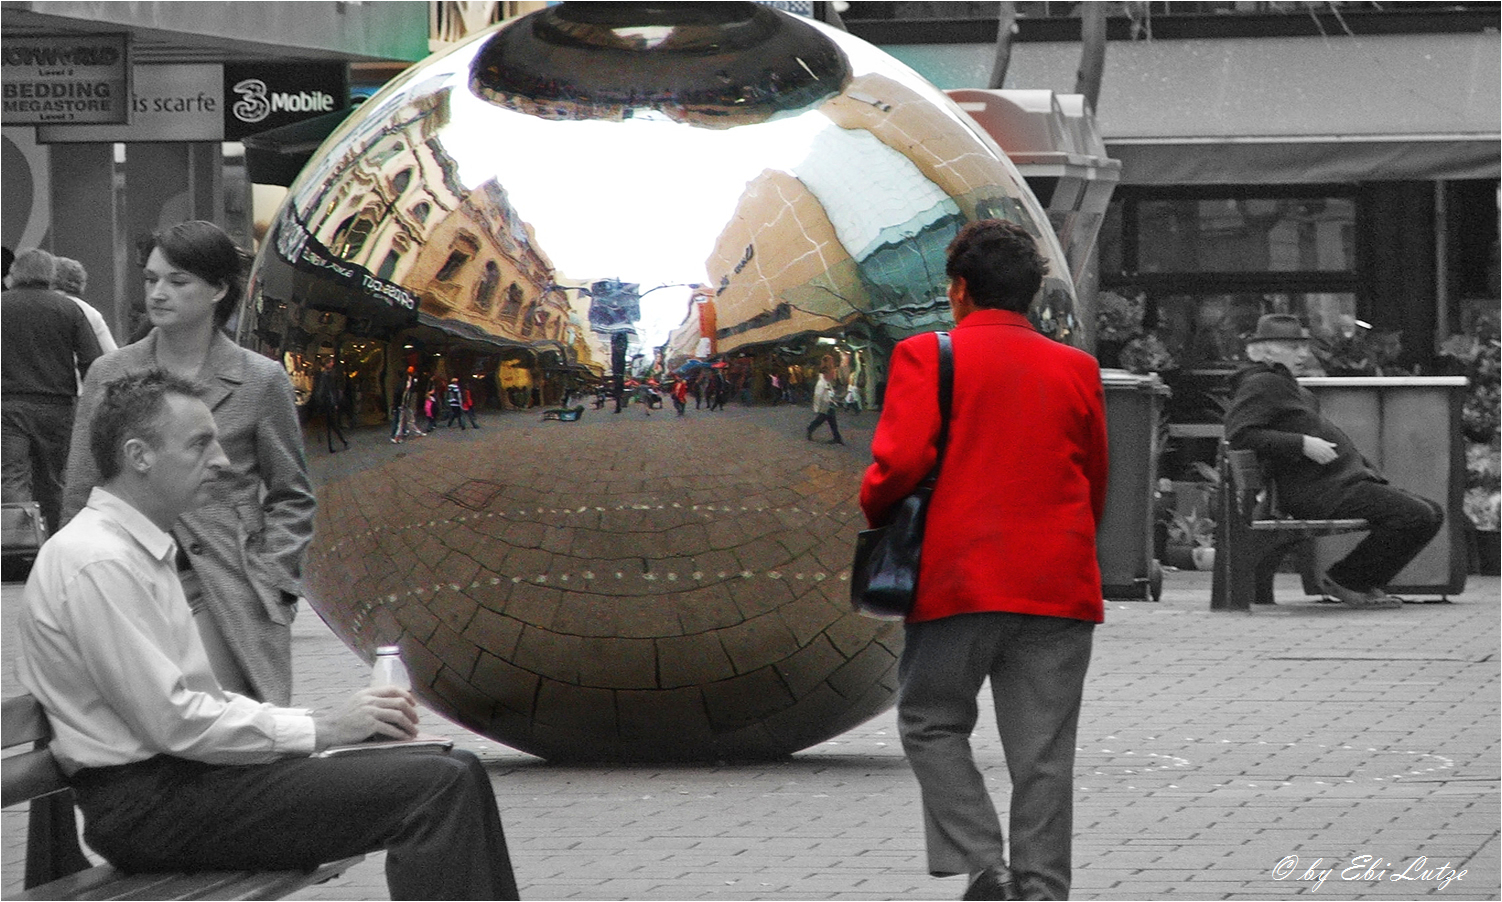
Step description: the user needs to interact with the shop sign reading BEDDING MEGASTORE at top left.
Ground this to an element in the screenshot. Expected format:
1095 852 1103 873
0 35 131 125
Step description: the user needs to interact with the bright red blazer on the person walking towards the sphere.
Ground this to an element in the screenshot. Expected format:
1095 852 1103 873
861 309 1108 623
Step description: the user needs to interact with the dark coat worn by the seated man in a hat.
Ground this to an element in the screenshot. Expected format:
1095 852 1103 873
1226 363 1386 518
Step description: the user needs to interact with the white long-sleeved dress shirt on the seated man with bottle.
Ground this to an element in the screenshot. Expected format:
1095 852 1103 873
17 488 314 774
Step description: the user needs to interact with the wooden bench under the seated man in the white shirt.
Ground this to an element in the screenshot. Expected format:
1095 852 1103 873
0 695 365 899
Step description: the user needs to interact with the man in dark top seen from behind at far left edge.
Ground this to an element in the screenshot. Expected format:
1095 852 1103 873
0 248 101 531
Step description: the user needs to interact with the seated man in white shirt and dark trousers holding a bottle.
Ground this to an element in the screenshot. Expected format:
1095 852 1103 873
17 371 517 899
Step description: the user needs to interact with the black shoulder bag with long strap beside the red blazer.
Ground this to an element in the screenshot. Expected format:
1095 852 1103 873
850 332 954 620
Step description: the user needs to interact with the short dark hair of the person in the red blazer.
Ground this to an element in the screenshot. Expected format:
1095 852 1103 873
945 219 1048 314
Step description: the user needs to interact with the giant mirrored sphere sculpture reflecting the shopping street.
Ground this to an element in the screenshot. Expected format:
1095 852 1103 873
239 3 1074 761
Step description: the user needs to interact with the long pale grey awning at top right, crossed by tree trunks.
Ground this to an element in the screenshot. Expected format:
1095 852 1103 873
883 30 1502 185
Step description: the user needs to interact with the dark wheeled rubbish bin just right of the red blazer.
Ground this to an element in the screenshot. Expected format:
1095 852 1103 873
1095 369 1169 602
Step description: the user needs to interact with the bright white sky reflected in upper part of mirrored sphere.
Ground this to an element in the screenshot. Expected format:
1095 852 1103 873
440 90 838 345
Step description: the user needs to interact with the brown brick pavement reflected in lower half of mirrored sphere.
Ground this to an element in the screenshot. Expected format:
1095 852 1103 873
300 407 900 761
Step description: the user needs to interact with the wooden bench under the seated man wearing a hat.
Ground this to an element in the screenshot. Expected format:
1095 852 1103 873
1211 443 1371 611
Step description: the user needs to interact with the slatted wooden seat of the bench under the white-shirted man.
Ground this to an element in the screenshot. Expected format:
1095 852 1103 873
15 855 365 900
